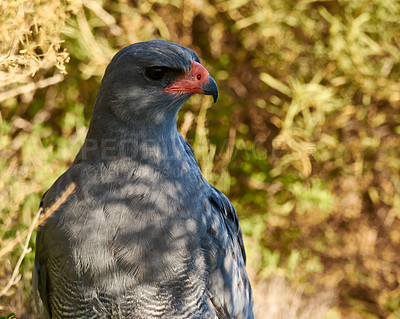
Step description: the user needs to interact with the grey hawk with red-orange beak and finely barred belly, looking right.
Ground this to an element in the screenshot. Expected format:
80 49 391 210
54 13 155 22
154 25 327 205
33 40 254 319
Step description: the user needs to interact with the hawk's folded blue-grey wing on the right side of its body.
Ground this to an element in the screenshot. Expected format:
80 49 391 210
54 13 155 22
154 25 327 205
203 186 253 319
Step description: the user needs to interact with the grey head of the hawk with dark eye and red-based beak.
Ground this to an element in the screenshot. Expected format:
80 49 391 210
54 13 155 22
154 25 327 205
93 40 218 129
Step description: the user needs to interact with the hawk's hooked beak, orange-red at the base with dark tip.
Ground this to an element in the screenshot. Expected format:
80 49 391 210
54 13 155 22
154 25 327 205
163 61 218 103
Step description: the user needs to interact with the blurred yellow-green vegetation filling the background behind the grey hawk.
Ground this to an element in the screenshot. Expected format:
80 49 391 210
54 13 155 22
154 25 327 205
0 0 400 318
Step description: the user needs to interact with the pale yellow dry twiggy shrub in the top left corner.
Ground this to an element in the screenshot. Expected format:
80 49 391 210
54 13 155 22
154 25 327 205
0 0 73 102
